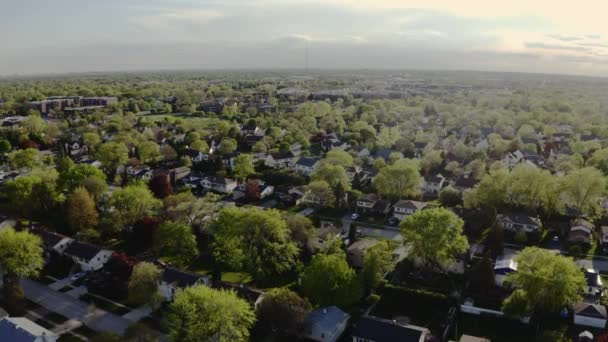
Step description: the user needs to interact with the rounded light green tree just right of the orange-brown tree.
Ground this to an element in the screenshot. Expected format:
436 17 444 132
109 184 162 225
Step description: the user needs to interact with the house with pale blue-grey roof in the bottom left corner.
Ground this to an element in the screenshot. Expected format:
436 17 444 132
0 317 59 342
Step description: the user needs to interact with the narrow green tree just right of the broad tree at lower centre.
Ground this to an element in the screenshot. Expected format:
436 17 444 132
361 243 393 293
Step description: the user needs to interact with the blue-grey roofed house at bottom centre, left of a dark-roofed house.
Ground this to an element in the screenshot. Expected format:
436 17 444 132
302 306 350 342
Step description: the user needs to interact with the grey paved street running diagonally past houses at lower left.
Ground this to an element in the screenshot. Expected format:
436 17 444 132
21 279 131 335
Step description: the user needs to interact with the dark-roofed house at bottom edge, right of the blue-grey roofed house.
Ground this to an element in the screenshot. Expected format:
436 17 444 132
352 316 430 342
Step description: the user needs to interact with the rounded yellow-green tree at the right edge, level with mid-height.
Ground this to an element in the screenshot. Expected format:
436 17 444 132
562 167 606 215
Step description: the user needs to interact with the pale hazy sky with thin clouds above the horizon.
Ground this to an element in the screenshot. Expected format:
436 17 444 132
0 0 608 76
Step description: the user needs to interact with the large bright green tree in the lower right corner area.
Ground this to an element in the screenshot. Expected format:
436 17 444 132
503 247 587 315
